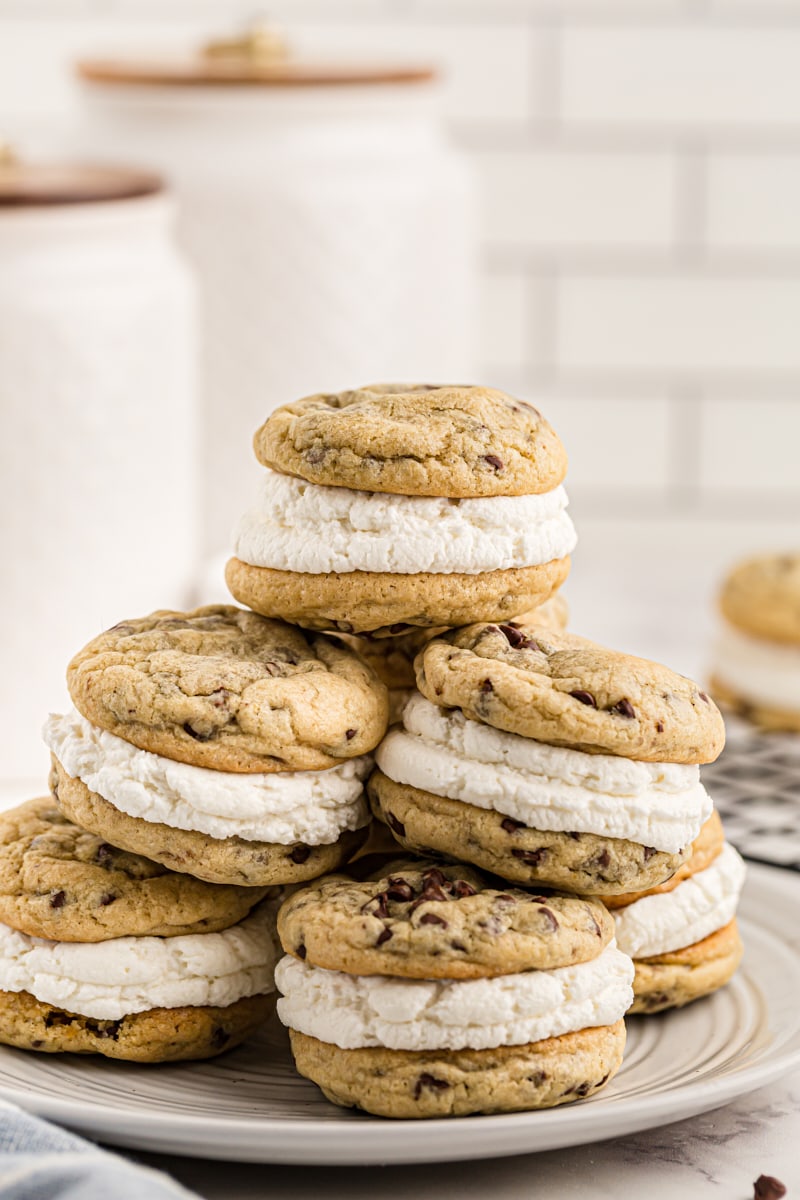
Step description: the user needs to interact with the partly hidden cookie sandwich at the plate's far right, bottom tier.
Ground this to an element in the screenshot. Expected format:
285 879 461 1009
606 812 745 1013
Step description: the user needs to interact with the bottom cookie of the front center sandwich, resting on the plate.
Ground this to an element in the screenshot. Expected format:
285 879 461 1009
289 1021 625 1117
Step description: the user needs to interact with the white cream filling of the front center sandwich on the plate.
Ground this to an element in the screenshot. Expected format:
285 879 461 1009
275 942 633 1050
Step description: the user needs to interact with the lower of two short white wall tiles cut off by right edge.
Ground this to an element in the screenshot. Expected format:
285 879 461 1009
700 400 800 489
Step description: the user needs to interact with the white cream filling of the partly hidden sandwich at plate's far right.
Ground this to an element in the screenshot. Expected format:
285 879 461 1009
614 845 746 959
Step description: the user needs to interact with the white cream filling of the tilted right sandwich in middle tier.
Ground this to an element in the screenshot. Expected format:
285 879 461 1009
375 694 712 854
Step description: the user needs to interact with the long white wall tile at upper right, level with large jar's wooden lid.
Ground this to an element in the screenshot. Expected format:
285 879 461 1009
561 23 800 131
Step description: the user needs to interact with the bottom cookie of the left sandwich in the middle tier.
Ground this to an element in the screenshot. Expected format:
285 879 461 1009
55 760 369 888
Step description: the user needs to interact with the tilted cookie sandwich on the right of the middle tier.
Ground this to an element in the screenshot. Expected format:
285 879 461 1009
367 623 724 896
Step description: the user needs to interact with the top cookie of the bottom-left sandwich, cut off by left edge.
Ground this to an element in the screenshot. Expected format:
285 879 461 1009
0 797 267 942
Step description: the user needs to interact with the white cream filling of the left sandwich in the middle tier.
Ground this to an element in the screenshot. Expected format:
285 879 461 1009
43 709 372 846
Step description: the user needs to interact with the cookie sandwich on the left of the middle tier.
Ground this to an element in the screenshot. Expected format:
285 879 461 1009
44 606 389 887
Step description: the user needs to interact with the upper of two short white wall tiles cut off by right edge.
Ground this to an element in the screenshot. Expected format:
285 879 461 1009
706 152 800 251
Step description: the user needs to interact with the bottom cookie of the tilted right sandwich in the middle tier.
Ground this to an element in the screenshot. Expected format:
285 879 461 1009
367 769 691 899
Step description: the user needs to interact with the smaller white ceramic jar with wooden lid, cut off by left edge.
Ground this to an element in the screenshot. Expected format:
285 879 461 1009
0 168 197 787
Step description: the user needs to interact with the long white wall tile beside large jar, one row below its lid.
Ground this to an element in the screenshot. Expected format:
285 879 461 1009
474 150 676 254
